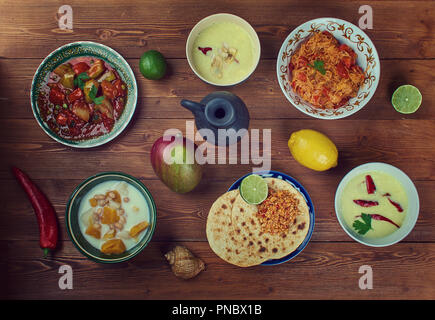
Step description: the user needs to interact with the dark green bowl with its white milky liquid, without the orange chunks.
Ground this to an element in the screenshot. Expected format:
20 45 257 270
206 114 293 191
65 172 157 263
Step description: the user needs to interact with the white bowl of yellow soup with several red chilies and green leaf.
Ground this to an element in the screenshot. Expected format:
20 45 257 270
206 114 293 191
335 162 420 247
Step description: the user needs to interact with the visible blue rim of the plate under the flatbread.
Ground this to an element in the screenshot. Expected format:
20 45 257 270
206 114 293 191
228 171 315 266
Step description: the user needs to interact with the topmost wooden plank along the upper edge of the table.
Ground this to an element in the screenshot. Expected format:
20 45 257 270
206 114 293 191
0 0 435 59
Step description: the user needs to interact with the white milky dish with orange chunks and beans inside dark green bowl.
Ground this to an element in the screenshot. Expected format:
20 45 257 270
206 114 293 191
79 181 150 254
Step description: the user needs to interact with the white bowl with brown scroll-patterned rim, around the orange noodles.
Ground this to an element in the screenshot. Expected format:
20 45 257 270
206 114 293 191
276 18 381 119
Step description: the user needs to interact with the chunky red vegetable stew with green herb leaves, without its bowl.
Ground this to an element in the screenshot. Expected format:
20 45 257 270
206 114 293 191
38 57 127 140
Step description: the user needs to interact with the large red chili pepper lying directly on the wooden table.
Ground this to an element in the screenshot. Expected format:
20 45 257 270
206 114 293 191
12 167 59 256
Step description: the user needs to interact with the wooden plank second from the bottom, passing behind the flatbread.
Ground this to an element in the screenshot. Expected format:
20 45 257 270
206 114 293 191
0 180 435 242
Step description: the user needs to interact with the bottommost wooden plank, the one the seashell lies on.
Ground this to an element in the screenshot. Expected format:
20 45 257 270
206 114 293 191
0 241 435 300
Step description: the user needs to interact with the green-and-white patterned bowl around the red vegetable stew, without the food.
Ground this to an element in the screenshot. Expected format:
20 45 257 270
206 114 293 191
30 41 137 148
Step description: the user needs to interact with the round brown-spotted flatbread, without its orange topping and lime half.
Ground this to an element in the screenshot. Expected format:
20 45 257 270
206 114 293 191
207 178 310 267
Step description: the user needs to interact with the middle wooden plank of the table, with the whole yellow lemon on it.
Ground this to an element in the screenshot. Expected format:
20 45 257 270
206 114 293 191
0 119 435 182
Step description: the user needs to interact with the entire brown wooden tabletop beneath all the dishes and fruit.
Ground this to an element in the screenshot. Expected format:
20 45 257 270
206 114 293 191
0 0 435 299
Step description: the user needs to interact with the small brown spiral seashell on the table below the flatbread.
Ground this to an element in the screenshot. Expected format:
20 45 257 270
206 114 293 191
165 246 205 279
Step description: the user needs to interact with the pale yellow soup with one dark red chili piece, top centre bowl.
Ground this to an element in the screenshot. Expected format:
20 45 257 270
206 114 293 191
192 21 256 85
